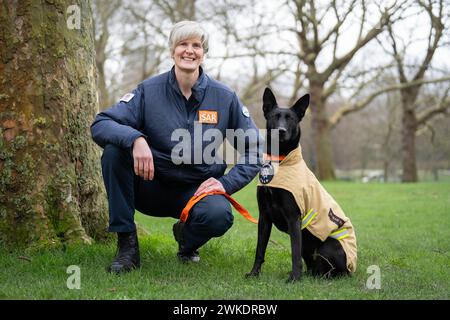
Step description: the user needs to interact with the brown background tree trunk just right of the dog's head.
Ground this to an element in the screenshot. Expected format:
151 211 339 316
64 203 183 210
310 84 336 180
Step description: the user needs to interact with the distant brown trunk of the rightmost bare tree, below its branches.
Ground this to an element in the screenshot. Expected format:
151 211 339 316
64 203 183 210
402 108 417 182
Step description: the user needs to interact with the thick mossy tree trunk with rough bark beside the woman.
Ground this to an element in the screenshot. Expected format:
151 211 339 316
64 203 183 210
0 0 107 247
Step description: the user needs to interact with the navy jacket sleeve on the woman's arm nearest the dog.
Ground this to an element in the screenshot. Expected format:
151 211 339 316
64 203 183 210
218 94 263 195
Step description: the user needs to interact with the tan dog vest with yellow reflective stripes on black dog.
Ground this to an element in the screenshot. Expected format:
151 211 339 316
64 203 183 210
258 146 357 272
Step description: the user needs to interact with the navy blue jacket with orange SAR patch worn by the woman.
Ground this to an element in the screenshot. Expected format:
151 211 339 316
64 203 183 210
91 68 262 194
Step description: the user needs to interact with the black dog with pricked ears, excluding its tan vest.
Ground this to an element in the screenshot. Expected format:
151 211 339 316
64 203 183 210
246 88 356 282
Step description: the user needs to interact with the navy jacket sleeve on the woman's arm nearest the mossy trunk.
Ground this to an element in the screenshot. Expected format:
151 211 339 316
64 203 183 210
91 85 146 148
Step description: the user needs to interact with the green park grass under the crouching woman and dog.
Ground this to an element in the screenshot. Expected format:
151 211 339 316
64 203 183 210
0 182 450 300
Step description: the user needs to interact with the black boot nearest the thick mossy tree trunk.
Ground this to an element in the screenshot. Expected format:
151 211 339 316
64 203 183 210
107 231 141 273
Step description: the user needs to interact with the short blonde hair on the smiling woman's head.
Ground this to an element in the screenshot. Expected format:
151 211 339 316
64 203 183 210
169 20 209 54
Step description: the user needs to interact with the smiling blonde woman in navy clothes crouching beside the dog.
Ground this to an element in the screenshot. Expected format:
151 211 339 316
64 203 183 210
91 21 260 273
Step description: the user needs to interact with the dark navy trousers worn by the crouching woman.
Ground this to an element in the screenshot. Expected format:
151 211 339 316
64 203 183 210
102 144 233 251
